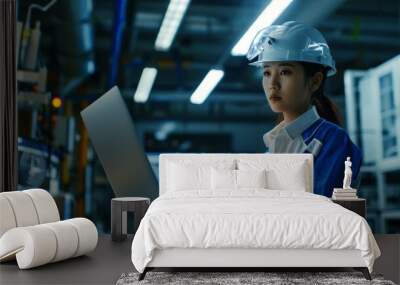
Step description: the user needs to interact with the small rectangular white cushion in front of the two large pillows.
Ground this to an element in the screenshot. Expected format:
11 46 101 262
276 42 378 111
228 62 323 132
211 168 267 190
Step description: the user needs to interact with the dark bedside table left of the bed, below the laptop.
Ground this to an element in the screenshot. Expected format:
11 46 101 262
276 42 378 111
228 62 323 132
111 197 150 241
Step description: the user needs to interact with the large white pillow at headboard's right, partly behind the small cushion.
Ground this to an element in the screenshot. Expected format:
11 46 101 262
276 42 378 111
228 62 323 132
238 159 309 192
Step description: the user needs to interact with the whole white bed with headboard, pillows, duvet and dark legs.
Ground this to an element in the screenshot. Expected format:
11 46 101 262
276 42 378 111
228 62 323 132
132 154 380 279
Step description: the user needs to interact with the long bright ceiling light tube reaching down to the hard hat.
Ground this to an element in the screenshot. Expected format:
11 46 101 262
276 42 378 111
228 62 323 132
231 0 293 56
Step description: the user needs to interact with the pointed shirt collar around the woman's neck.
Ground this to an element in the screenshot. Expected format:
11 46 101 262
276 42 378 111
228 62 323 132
263 106 320 146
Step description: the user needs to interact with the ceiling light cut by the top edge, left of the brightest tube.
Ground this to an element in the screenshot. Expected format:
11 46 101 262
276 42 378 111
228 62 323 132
155 0 190 51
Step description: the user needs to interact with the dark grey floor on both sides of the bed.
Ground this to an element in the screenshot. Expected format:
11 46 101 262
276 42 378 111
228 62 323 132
0 234 400 285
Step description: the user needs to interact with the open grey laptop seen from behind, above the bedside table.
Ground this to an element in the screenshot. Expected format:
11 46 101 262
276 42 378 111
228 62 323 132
81 86 158 200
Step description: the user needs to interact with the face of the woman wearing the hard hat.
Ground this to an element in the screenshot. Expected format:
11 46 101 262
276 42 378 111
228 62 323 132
263 62 311 114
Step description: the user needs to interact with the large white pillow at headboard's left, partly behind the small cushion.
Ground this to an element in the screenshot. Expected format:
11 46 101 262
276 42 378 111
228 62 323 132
166 160 236 191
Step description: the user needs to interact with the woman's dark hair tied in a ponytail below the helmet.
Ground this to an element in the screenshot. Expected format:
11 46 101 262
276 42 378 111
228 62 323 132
278 62 342 126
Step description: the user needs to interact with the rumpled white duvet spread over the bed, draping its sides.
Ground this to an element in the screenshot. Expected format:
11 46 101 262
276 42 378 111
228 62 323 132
132 189 380 272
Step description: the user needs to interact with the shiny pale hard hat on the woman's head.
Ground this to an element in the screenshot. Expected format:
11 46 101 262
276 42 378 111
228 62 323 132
247 21 336 76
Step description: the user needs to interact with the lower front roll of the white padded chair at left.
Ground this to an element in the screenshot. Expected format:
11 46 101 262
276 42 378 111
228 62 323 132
0 218 98 269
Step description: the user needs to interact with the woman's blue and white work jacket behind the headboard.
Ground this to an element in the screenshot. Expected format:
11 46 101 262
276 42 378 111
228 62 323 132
263 106 362 197
